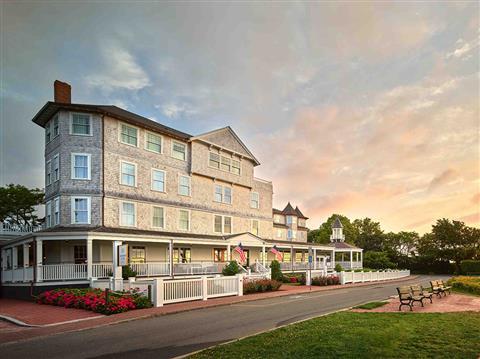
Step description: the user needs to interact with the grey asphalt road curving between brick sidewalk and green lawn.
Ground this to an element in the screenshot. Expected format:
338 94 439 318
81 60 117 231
0 276 450 359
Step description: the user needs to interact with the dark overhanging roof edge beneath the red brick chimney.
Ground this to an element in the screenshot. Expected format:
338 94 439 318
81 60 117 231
32 101 192 141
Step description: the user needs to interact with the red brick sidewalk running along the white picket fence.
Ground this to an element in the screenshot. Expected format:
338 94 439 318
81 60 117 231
0 276 415 344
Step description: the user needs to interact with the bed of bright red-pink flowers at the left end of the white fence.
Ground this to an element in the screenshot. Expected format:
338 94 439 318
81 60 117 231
36 288 152 315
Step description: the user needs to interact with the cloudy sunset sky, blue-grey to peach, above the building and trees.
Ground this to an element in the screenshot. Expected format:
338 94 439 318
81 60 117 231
0 0 480 233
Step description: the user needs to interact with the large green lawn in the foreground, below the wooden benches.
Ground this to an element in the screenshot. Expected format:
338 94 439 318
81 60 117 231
193 312 480 359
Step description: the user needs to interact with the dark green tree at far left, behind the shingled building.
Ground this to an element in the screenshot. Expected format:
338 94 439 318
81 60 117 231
0 184 44 225
